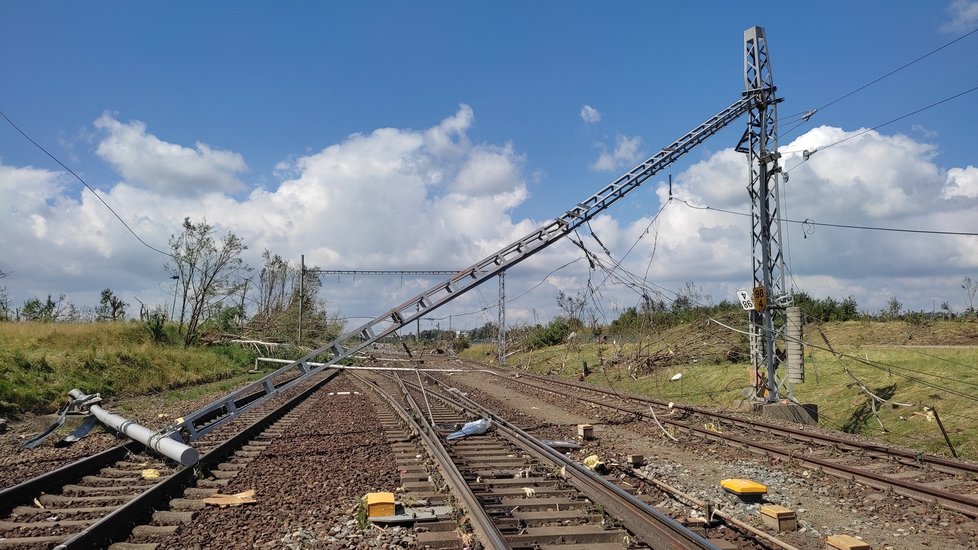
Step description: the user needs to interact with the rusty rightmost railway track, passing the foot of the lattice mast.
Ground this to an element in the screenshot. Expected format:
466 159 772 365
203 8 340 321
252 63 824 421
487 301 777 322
464 366 978 518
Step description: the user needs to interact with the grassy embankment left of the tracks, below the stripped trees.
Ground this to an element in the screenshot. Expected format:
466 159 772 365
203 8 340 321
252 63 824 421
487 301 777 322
0 322 264 416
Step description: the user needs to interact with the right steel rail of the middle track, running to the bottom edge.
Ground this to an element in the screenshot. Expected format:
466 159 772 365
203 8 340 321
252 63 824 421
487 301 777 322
412 375 718 550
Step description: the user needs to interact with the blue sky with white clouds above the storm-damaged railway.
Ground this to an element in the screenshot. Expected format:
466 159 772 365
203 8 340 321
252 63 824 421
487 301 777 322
0 0 978 330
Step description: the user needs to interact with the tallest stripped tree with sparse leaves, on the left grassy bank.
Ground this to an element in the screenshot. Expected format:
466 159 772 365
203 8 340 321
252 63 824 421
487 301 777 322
166 218 248 346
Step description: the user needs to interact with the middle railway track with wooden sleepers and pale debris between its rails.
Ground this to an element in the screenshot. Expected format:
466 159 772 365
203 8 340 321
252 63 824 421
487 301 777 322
358 368 748 549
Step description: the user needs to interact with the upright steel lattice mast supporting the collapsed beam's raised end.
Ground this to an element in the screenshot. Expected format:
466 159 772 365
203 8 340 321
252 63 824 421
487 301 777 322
737 27 791 402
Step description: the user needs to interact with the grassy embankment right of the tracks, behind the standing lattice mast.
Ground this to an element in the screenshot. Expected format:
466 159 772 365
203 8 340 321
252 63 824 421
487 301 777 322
464 321 978 459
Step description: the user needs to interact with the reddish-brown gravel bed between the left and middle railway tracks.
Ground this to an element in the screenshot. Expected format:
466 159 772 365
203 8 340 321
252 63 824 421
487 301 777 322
151 381 411 549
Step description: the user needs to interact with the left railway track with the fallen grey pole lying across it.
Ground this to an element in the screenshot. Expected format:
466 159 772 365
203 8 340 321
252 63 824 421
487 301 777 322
0 371 336 548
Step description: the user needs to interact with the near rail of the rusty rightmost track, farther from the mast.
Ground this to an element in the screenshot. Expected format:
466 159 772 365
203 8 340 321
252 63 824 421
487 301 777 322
488 375 978 517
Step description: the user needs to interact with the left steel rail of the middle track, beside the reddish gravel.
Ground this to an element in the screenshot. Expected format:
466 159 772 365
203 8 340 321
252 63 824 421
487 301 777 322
353 374 512 550
